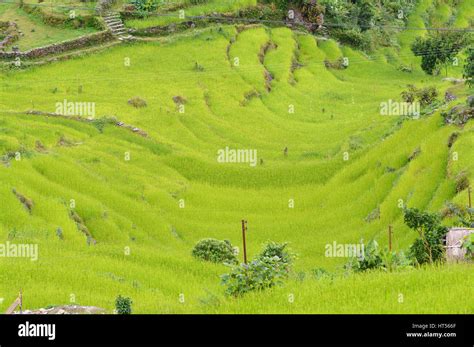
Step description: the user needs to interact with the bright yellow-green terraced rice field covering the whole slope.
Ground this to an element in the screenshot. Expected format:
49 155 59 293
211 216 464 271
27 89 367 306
0 0 474 313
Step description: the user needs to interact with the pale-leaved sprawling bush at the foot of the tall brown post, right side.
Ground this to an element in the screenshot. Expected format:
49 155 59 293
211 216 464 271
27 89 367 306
221 242 295 296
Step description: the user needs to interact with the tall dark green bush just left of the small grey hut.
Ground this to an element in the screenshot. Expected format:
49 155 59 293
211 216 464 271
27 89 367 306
404 208 448 264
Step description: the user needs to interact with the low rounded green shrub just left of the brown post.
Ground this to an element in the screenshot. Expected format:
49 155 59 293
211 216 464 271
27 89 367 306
192 238 238 264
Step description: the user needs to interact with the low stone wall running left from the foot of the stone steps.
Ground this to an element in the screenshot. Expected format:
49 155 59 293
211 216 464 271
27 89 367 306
0 30 115 60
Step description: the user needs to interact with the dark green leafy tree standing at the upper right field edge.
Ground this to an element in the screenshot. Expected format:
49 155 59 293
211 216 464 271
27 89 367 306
411 31 467 75
